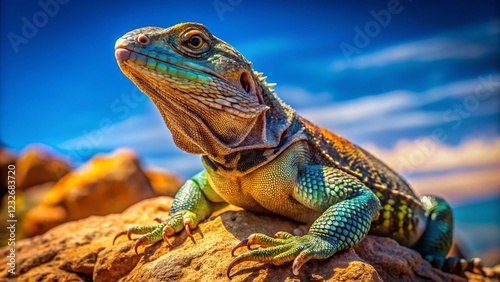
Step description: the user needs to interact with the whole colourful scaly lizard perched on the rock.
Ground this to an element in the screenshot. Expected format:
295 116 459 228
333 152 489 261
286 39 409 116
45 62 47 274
115 23 480 276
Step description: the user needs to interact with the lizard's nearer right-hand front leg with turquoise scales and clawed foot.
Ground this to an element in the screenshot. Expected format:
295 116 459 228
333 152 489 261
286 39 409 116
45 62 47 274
227 166 380 276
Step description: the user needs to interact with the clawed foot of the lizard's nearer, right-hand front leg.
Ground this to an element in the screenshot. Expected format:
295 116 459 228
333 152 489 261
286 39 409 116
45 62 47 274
227 232 336 278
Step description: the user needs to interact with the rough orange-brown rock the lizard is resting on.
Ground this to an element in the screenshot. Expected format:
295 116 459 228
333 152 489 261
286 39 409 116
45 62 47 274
0 197 498 282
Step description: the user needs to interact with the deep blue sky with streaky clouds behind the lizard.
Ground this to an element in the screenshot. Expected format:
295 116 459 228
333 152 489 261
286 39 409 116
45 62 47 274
0 0 500 258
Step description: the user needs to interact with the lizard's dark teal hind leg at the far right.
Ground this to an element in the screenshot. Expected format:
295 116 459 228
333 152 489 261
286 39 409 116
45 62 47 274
413 196 481 275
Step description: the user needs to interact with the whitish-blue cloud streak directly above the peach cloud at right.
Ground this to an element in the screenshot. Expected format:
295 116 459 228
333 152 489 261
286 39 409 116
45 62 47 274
292 73 500 135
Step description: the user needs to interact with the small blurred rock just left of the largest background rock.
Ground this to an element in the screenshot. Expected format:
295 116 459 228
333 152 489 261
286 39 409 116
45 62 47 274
16 145 70 191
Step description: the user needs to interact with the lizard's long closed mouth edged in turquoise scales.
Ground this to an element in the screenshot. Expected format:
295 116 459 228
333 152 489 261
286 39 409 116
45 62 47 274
115 47 226 84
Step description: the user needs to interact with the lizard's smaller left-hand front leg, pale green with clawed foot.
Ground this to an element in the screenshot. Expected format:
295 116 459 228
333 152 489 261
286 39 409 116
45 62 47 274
113 171 222 253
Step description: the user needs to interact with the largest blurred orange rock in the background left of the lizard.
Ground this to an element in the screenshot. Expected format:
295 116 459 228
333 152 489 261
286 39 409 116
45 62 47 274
23 150 154 237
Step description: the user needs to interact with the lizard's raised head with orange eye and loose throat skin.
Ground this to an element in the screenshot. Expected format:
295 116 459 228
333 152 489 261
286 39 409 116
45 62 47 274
115 23 291 163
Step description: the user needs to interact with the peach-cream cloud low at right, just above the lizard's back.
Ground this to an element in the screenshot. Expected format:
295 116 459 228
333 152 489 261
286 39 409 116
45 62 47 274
363 138 500 201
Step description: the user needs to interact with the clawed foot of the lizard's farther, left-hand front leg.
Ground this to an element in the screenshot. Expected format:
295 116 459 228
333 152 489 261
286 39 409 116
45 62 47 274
113 211 196 254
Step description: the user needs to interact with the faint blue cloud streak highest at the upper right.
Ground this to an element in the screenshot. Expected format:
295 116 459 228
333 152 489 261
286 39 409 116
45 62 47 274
330 21 500 71
